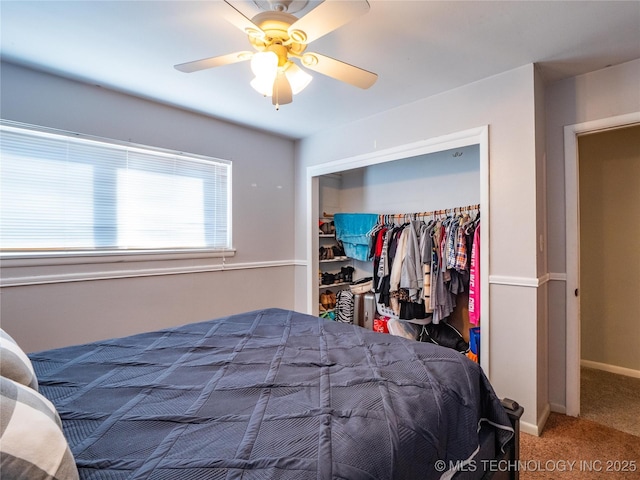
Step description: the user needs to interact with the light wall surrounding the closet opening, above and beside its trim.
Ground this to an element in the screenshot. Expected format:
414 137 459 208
296 65 547 431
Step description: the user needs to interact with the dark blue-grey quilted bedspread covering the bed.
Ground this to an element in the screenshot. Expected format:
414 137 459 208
30 309 514 480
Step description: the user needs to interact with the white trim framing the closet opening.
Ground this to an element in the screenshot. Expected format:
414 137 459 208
305 125 491 379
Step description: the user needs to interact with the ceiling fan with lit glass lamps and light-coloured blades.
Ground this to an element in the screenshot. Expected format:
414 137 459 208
175 0 378 109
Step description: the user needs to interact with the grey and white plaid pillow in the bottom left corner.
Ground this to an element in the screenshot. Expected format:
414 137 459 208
0 377 79 480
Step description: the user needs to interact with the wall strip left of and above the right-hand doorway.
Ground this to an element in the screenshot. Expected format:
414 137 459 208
545 59 640 411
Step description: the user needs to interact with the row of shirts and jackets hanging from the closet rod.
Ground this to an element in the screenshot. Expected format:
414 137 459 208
369 206 479 324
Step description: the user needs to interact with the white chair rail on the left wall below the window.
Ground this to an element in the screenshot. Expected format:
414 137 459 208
0 260 298 288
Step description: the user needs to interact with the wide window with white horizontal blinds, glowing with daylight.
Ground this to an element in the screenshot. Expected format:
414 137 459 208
0 122 231 255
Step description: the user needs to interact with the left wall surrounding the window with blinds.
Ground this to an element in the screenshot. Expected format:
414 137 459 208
0 63 295 351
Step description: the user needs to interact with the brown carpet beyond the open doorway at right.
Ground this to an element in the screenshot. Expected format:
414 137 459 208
580 367 640 436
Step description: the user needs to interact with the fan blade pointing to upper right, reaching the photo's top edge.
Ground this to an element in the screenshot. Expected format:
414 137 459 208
288 0 369 44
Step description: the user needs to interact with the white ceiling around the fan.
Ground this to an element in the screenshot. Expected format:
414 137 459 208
0 0 640 138
